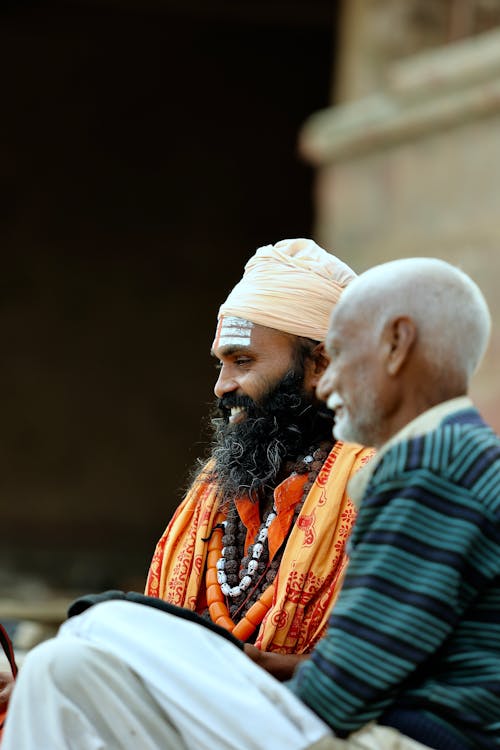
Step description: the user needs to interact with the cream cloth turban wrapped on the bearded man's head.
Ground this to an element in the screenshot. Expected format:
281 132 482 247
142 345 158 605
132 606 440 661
219 239 356 341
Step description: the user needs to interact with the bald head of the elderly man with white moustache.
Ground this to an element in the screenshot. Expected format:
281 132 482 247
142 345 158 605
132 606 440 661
318 258 491 445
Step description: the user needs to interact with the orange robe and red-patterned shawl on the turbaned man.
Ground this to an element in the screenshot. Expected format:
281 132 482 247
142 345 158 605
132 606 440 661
146 442 374 654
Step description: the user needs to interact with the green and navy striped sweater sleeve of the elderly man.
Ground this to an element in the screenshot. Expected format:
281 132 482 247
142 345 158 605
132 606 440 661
288 462 498 736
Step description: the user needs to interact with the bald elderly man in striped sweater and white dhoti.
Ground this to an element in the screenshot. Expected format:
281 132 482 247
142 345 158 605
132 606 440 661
3 258 500 750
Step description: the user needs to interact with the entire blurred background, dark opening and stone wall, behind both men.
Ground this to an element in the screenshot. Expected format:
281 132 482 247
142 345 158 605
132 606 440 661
0 0 500 640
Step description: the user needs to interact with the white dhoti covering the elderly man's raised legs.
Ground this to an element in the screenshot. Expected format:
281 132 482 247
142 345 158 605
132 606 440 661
2 601 430 750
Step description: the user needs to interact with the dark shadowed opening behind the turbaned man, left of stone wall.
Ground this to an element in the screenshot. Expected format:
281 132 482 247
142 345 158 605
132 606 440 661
0 0 335 589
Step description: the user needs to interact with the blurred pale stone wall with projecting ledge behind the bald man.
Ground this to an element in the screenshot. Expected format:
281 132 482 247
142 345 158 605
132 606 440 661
300 29 500 430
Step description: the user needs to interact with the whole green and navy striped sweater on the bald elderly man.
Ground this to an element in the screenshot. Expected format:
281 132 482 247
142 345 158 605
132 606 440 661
288 409 500 750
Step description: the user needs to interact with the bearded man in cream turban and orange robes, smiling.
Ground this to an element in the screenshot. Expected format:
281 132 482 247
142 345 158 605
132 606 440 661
146 239 371 679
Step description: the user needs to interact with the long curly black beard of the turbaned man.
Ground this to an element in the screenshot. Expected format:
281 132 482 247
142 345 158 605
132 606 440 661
210 372 333 502
